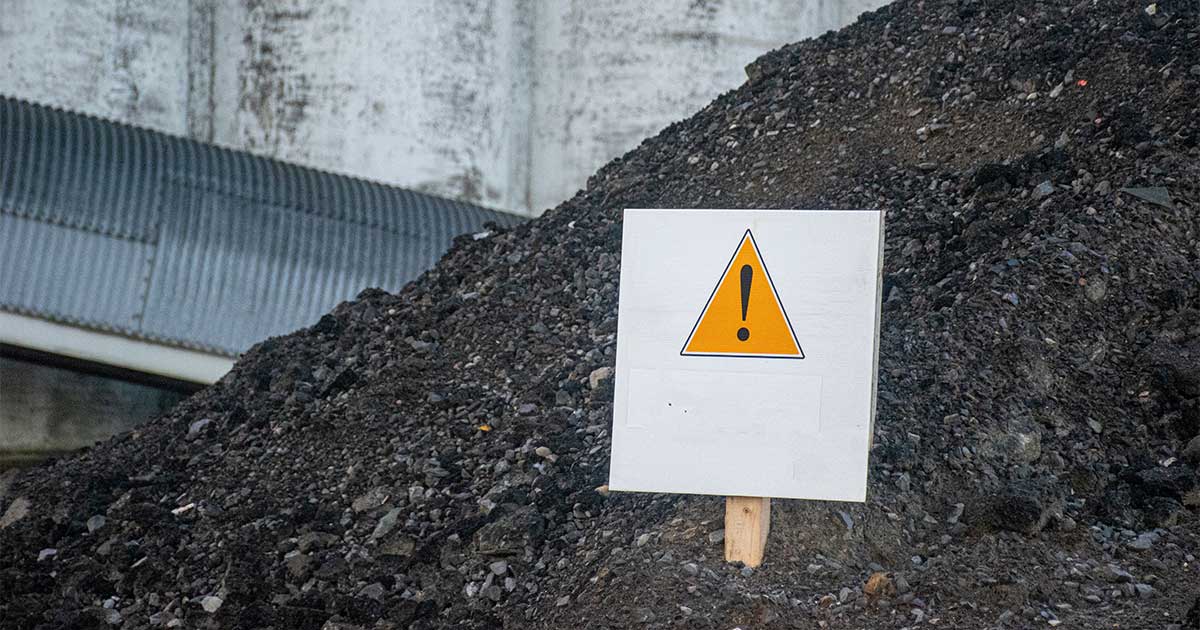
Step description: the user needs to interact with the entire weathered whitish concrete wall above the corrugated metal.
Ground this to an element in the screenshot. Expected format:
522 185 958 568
0 0 883 215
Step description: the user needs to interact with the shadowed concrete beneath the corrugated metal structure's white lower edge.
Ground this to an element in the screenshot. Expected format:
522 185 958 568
0 356 184 468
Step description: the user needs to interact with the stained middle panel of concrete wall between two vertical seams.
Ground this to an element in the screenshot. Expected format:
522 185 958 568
204 0 532 209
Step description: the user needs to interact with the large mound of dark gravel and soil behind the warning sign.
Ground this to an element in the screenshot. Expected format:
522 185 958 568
0 0 1200 629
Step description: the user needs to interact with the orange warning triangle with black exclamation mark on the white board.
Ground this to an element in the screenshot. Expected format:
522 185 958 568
679 229 804 359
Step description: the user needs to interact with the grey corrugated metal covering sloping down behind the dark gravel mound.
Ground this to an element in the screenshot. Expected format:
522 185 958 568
0 97 518 355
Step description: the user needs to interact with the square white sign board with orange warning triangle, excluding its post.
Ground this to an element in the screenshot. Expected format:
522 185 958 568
608 210 883 502
